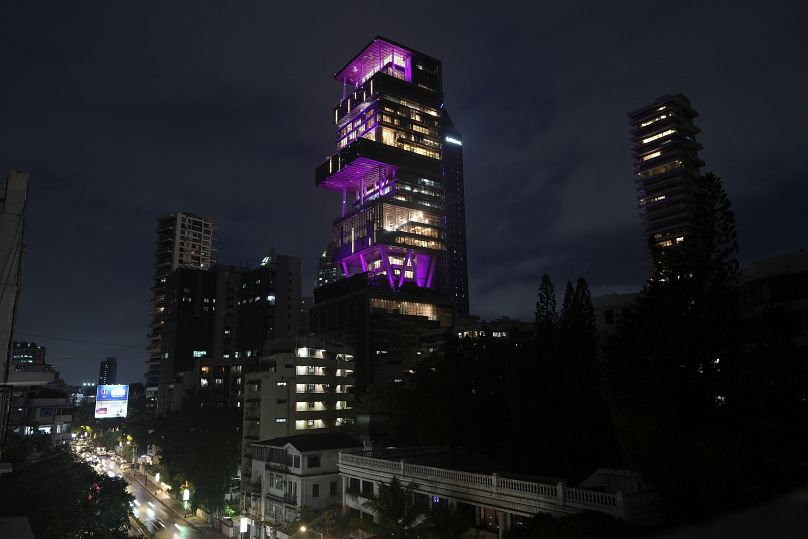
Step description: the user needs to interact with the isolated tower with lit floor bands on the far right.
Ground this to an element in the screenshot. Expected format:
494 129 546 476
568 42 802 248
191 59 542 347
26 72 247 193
628 94 704 253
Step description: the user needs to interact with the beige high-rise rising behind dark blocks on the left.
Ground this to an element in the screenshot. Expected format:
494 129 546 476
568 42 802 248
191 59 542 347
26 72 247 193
145 213 216 412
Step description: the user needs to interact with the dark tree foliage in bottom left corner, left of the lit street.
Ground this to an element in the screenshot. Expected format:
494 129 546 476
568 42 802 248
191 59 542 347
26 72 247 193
0 435 132 539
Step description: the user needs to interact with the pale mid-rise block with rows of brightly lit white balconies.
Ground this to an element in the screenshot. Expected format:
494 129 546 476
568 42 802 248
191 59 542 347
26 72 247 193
241 340 354 502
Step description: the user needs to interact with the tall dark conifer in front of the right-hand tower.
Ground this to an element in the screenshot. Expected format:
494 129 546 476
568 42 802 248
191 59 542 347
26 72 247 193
604 173 765 522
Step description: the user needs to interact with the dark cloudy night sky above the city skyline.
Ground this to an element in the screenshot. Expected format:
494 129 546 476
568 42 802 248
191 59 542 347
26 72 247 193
0 1 808 383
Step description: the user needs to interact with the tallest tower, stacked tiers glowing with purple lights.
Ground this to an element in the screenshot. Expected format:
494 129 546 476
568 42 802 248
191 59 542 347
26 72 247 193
309 37 460 389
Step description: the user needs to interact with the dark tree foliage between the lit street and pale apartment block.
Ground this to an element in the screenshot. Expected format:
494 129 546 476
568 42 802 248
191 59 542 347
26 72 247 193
154 408 241 513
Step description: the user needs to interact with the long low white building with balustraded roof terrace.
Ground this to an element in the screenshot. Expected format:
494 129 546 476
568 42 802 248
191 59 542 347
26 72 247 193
339 448 659 538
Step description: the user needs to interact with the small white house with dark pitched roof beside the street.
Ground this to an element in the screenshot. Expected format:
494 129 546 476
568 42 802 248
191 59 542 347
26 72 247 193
245 433 361 537
